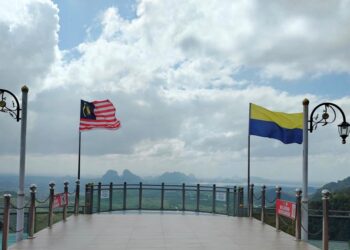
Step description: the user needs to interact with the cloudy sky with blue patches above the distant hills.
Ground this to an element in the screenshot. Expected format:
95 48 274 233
0 0 350 182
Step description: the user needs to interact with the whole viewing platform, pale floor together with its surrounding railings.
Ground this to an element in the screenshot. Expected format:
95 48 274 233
0 182 350 250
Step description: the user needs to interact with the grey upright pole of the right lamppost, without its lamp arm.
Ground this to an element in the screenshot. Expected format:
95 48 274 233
301 98 309 241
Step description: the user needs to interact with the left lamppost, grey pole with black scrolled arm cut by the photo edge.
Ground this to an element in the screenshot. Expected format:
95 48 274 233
0 85 29 241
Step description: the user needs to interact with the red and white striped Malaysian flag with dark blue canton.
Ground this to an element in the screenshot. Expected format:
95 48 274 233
79 100 120 131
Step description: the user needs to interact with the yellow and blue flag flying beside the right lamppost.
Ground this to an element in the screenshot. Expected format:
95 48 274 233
249 103 303 144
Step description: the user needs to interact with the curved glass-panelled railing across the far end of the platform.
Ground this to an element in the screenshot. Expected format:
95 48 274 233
85 182 247 216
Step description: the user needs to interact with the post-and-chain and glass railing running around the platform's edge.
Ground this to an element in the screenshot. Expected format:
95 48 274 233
2 181 340 250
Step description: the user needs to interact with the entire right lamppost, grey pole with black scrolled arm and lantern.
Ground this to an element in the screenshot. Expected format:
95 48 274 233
301 99 350 241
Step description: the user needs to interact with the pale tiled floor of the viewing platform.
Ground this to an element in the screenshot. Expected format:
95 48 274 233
9 212 317 250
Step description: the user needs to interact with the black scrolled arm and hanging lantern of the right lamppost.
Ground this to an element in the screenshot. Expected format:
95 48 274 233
309 102 350 144
